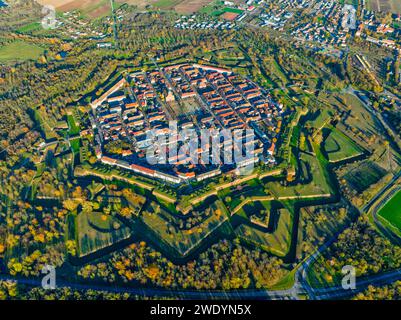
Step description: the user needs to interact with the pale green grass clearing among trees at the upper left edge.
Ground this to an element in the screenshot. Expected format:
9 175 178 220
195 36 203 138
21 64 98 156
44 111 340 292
0 41 44 64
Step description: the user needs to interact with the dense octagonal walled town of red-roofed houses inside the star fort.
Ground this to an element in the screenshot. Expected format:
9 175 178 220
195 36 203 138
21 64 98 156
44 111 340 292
92 64 282 184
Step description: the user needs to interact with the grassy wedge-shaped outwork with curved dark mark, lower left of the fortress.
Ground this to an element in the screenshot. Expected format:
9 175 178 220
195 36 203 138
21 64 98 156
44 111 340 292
76 212 131 257
